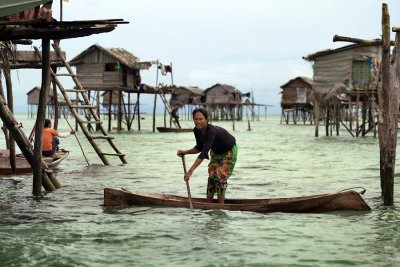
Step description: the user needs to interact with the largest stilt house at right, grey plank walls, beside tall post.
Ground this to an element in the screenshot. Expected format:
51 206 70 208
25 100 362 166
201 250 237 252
304 44 381 136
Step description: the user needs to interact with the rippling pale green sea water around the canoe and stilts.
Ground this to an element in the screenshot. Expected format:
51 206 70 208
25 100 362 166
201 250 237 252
0 115 400 266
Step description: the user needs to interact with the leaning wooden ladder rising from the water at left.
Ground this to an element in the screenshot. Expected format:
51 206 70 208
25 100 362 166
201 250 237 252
35 43 127 165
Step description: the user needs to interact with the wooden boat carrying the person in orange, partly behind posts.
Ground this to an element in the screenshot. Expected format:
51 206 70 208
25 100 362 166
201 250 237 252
0 149 69 175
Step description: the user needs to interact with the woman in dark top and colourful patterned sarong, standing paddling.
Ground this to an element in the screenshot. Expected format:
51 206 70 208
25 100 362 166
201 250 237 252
177 108 238 203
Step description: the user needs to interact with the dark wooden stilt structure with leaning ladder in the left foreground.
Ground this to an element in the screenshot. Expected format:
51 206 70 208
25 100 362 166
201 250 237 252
0 0 126 195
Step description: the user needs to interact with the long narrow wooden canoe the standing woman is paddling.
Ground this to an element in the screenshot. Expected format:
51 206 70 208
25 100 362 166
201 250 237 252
104 188 371 213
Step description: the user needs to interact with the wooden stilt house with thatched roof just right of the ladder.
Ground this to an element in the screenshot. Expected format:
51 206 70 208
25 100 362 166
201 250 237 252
69 44 151 130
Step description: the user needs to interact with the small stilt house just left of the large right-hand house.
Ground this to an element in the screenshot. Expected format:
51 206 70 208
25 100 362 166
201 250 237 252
281 77 313 123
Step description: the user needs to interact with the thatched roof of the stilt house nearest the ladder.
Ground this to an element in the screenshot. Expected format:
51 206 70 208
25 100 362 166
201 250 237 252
69 44 143 69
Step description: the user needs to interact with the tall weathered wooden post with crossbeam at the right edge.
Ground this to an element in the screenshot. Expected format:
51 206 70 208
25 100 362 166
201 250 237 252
333 3 400 206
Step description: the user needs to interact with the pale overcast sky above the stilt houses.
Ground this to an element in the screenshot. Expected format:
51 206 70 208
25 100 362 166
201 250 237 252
8 0 400 114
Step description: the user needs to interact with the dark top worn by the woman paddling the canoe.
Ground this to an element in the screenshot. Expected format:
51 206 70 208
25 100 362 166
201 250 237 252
193 124 236 159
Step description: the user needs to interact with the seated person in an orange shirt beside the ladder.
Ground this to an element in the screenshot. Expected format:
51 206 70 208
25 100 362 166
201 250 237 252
42 119 75 157
